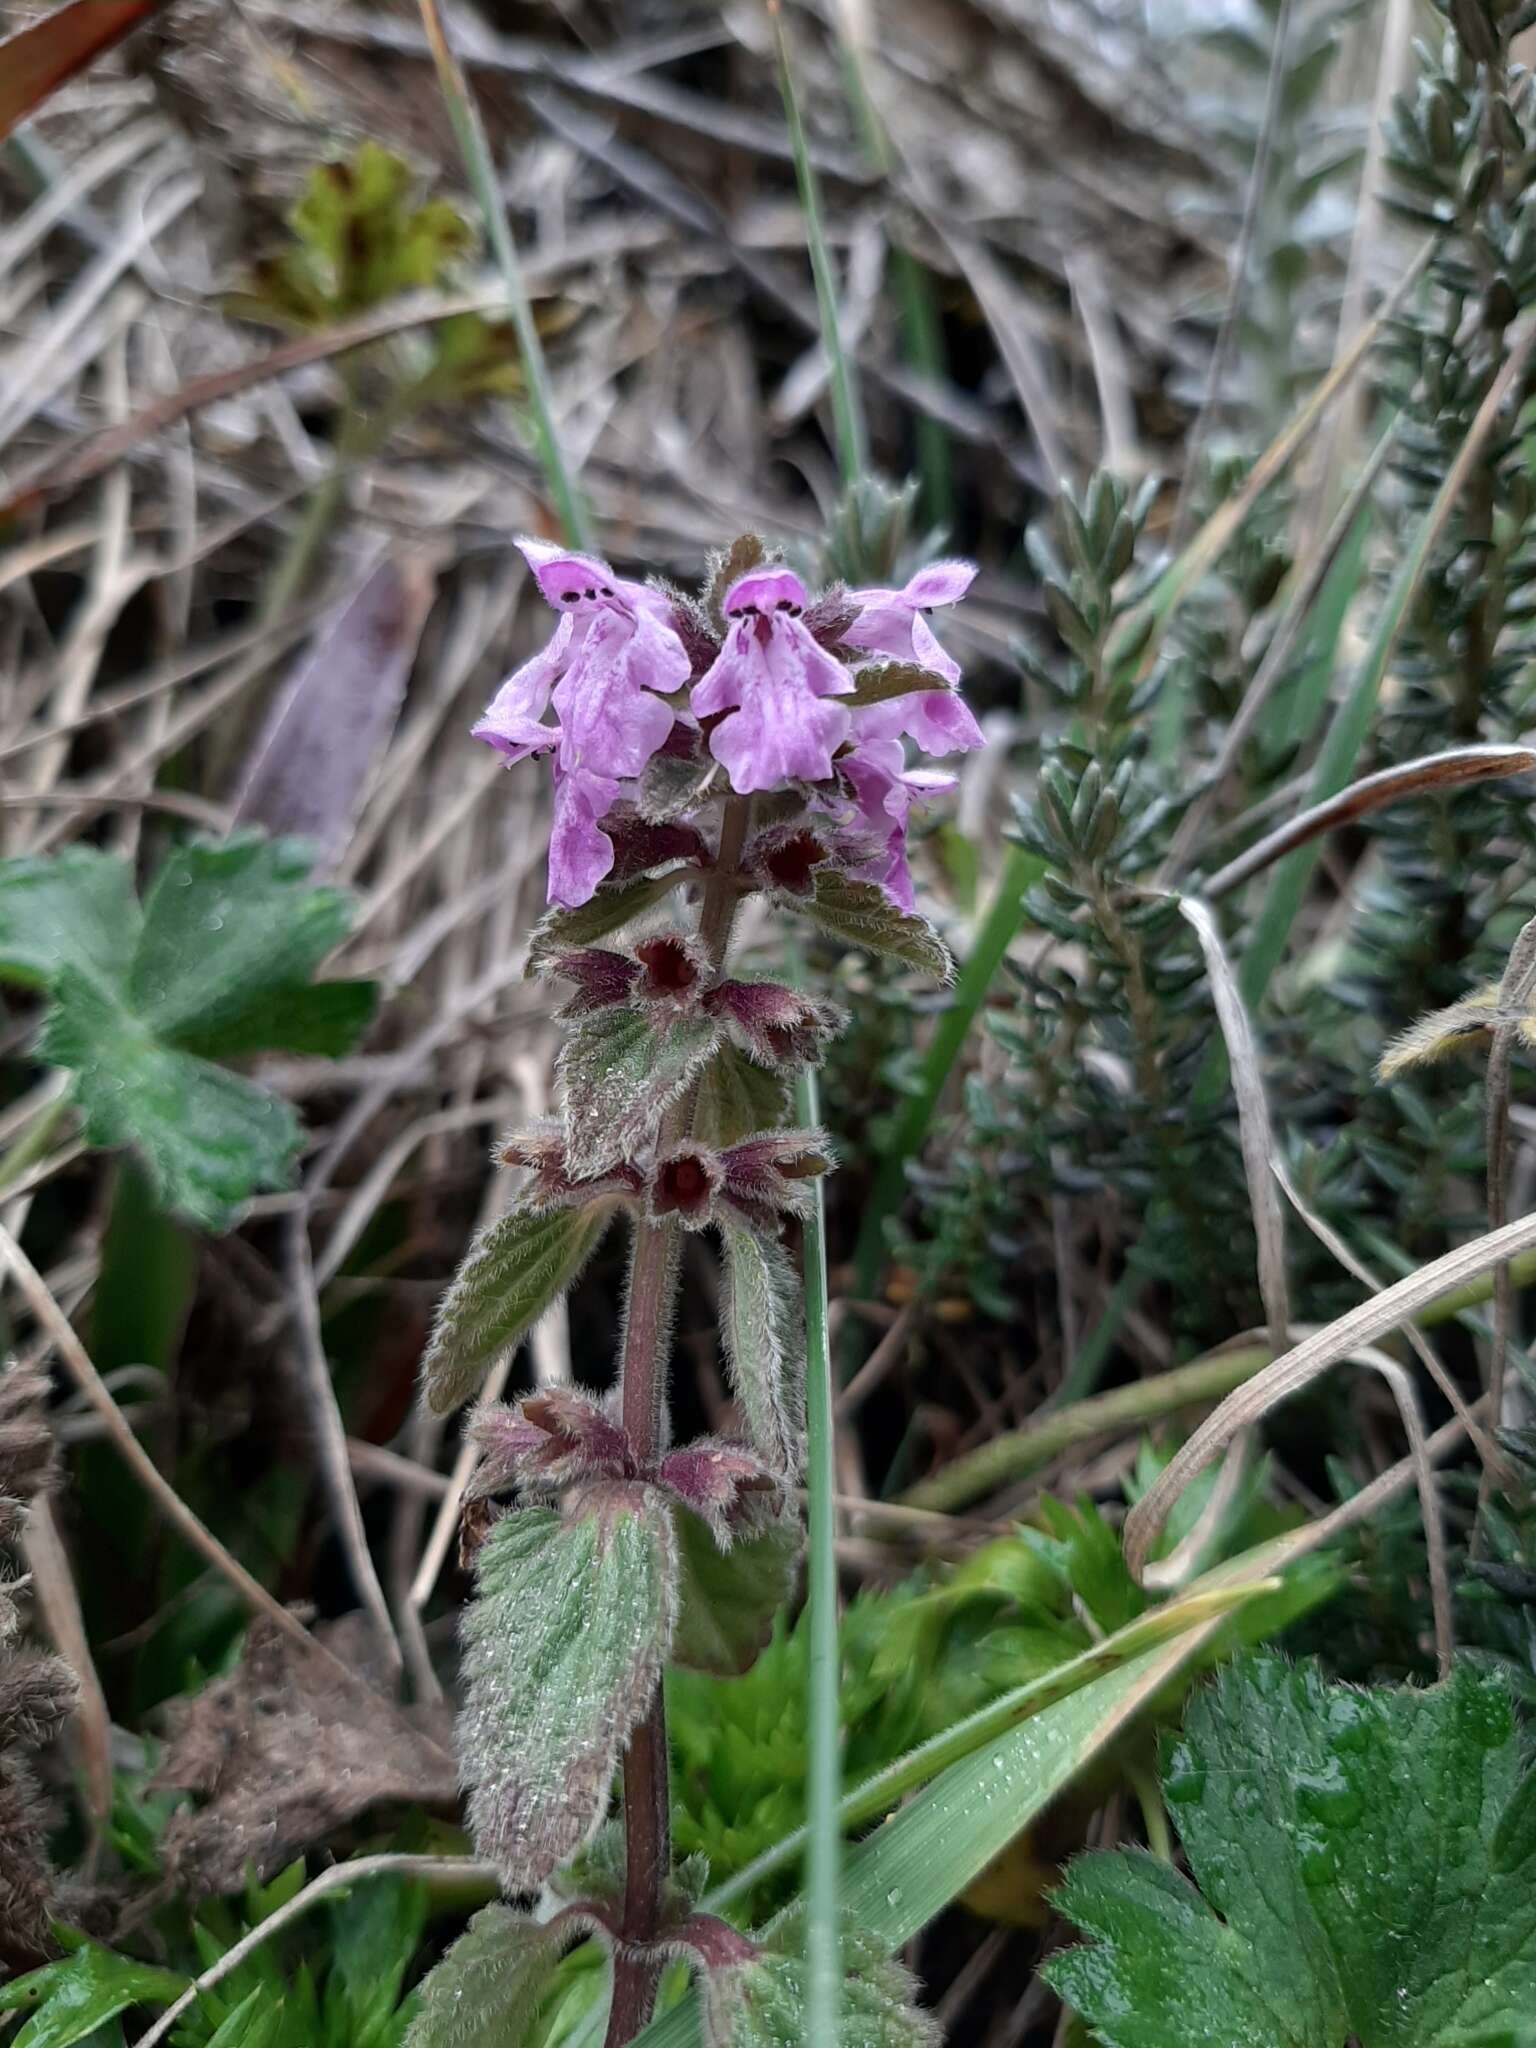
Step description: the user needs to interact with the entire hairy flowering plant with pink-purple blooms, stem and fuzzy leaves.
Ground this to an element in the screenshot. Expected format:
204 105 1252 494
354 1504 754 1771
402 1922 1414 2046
412 539 981 2048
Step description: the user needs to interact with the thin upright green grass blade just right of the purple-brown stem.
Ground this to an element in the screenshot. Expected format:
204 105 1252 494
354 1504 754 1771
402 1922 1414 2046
795 1067 842 2048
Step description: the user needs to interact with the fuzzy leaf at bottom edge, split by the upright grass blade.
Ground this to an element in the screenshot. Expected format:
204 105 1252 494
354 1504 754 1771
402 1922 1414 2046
702 1927 940 2048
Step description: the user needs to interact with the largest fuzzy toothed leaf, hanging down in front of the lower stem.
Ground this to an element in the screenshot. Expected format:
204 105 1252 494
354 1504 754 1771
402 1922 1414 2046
459 1487 678 1892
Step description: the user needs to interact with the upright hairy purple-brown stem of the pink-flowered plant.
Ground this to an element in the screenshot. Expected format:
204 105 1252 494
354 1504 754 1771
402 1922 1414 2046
604 797 752 2048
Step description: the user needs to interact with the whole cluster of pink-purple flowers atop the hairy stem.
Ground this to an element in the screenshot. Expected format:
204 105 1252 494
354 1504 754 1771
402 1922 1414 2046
475 541 981 911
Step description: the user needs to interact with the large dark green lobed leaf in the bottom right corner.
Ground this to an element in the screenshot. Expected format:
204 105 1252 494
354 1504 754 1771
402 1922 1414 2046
1047 1655 1536 2048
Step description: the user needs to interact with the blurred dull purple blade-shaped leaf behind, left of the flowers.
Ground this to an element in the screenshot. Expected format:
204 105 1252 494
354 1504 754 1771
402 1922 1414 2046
236 557 436 868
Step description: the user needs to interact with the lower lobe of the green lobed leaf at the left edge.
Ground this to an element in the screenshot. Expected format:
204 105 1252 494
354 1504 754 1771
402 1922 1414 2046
37 967 303 1231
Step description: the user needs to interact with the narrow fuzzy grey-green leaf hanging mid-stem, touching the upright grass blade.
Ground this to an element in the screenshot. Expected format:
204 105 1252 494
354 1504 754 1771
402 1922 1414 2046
721 1223 805 1477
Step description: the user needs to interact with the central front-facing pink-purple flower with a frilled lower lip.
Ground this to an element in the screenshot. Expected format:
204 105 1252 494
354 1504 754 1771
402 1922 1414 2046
690 569 854 797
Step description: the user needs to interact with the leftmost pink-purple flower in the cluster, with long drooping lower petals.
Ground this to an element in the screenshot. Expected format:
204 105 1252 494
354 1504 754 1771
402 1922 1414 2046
473 541 692 905
